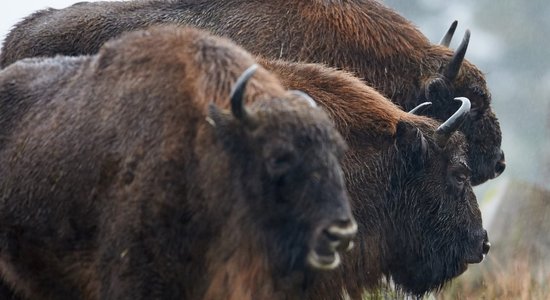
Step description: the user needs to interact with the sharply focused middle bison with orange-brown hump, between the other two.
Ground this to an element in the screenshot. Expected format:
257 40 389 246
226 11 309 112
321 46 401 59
258 59 490 300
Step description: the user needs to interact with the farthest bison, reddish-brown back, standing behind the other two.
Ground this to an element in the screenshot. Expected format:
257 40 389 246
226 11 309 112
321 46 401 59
0 0 505 185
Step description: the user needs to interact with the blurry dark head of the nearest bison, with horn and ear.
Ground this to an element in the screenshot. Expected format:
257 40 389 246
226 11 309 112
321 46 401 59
209 65 357 269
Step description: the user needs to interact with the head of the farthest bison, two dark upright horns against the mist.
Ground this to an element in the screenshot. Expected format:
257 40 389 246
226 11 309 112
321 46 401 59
418 25 506 185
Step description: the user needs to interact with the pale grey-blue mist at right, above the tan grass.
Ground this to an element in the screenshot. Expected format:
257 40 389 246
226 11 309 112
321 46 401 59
385 0 550 189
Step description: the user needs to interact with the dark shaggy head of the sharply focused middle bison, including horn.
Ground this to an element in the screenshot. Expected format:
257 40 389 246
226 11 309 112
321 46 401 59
384 98 490 295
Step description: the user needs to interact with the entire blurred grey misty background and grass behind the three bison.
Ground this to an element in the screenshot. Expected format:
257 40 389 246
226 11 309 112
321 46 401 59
0 0 550 299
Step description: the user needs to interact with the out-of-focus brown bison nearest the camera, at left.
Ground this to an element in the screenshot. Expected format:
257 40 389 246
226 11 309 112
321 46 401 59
0 27 357 300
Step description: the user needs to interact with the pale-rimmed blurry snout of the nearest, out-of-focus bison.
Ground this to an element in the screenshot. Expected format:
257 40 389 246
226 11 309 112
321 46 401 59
307 219 357 270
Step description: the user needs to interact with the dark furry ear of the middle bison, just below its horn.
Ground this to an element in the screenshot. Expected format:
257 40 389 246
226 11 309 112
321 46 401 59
395 121 428 162
